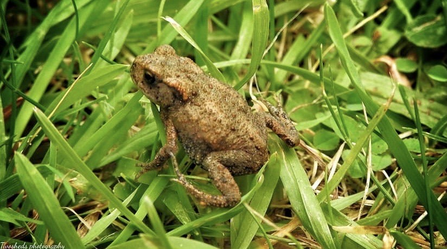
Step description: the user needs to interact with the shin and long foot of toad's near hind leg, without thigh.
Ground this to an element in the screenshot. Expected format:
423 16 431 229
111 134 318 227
171 153 241 207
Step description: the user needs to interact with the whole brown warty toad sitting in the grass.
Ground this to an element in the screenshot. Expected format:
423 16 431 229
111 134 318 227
130 45 300 207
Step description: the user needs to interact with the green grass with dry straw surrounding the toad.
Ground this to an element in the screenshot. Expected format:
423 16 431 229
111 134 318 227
0 0 447 248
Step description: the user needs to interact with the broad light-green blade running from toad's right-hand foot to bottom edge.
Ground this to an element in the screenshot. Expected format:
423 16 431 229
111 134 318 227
278 143 337 248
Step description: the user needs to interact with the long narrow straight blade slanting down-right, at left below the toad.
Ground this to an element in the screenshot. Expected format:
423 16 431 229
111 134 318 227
34 109 155 236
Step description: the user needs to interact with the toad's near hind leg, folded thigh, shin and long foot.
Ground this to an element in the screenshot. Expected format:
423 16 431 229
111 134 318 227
173 150 262 207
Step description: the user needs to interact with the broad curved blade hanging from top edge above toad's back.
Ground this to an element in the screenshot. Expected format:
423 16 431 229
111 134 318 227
234 0 270 90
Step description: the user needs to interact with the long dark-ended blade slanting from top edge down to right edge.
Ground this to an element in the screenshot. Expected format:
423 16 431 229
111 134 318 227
324 4 447 236
